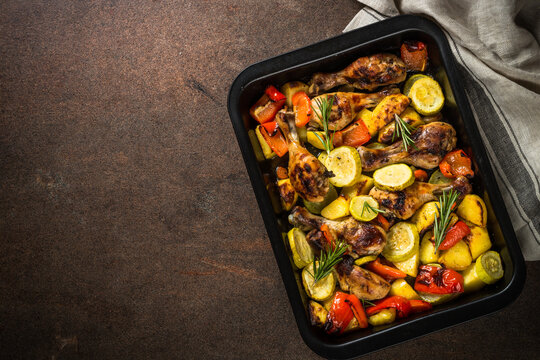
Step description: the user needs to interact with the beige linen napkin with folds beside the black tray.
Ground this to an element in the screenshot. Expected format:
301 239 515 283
344 0 540 261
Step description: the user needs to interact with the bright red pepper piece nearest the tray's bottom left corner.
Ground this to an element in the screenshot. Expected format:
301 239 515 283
324 291 368 334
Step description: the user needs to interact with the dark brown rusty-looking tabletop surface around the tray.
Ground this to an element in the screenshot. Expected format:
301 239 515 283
0 0 540 359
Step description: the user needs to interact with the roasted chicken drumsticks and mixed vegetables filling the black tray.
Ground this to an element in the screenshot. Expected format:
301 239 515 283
249 41 503 334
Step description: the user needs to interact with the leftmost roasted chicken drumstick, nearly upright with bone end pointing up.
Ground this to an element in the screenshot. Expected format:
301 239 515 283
276 110 330 202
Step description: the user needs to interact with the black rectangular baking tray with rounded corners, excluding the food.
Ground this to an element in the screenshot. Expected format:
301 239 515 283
228 15 525 359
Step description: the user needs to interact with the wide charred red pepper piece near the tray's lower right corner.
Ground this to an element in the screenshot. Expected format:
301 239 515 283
414 265 463 294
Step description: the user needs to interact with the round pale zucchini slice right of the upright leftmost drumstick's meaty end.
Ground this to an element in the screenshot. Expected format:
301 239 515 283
324 146 362 187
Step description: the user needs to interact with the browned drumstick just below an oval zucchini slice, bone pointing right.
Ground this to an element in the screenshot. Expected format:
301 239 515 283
369 176 472 220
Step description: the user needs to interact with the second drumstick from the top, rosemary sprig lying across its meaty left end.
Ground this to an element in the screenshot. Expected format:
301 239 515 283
311 87 399 130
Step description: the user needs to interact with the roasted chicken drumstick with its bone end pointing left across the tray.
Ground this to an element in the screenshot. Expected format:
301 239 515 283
289 206 386 256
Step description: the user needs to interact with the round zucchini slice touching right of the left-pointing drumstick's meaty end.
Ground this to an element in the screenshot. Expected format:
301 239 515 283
382 221 420 263
